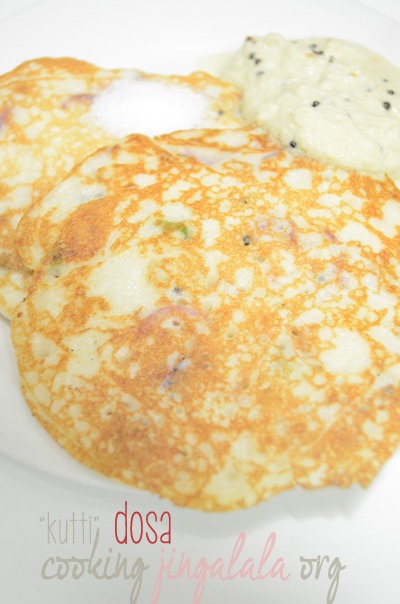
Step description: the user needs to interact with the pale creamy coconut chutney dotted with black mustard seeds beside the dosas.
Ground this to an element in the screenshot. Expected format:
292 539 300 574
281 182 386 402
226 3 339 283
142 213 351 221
221 34 400 181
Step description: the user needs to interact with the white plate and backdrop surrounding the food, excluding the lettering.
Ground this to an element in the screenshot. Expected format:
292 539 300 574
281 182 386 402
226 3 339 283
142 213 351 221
0 0 400 604
